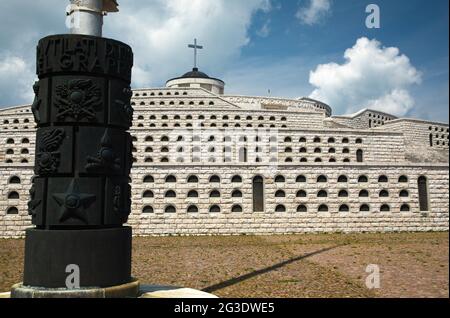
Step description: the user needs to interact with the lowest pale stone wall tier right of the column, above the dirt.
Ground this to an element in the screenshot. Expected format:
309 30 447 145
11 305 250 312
130 165 449 235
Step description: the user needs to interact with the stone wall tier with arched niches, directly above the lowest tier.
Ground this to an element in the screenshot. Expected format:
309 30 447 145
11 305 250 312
131 128 405 163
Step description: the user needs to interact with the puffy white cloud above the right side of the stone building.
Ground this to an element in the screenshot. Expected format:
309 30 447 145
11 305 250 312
309 37 421 116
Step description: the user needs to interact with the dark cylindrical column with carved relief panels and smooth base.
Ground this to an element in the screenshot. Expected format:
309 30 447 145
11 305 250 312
24 35 133 288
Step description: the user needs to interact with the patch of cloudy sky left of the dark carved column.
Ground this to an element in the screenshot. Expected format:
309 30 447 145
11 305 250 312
0 0 62 108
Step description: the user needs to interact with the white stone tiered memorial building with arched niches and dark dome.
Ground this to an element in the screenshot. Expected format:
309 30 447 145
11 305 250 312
0 68 449 238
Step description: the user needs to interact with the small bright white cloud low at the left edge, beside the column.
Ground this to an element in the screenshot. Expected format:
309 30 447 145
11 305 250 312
0 54 35 105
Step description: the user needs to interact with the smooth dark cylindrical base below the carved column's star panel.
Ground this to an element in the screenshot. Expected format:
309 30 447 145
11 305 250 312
23 227 132 289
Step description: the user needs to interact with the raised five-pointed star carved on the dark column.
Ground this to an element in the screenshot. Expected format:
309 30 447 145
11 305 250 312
53 179 96 224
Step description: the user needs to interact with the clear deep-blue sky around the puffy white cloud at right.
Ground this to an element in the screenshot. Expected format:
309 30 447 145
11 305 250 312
234 0 449 122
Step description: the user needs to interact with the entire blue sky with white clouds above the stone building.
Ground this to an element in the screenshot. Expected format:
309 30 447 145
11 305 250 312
0 0 449 122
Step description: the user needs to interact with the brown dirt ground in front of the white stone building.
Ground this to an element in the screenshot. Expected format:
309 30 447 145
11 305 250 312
0 233 449 298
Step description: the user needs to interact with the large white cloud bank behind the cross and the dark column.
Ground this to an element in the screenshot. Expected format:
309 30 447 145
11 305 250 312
0 0 272 106
